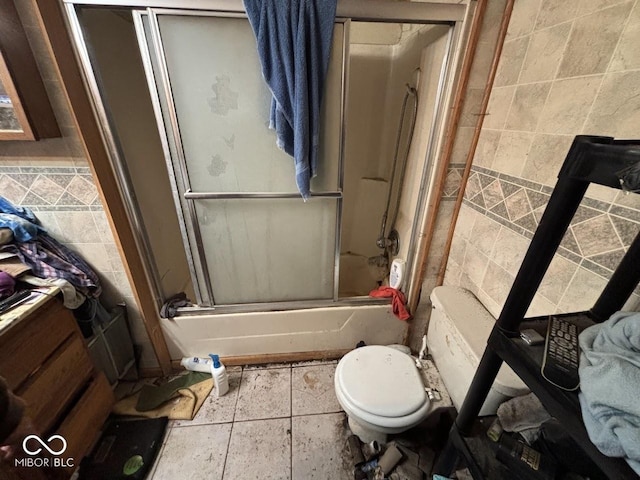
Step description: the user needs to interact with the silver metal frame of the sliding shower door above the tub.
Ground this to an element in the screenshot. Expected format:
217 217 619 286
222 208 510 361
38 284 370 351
62 0 467 315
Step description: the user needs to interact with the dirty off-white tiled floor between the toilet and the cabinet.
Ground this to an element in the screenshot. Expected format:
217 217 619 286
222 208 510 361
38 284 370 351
148 362 353 480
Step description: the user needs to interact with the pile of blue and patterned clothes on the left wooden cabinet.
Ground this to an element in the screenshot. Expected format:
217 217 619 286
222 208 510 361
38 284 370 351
0 196 102 310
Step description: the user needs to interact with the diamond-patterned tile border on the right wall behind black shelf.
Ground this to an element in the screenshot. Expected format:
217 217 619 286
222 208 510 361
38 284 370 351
443 164 640 278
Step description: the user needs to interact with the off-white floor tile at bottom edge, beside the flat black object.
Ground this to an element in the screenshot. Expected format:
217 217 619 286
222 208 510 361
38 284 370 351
151 423 231 480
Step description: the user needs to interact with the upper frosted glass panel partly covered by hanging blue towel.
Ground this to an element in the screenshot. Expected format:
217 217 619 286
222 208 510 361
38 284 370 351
158 15 342 192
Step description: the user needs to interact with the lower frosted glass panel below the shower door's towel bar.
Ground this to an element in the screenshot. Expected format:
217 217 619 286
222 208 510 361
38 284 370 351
196 198 337 304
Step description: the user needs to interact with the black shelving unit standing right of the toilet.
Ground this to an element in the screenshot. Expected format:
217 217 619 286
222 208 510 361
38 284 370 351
436 136 640 480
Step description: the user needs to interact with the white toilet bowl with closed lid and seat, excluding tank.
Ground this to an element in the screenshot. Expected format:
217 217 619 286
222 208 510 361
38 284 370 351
335 345 432 443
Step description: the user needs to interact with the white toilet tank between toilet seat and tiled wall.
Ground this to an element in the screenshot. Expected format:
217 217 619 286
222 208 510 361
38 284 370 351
427 286 529 415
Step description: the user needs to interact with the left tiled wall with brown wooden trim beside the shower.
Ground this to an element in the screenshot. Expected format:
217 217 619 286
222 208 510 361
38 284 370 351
0 0 157 367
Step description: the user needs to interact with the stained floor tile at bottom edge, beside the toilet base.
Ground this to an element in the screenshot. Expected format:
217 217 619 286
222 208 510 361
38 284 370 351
291 413 353 480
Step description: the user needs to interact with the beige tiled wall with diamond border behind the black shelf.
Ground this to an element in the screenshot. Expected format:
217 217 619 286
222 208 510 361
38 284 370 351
445 0 640 315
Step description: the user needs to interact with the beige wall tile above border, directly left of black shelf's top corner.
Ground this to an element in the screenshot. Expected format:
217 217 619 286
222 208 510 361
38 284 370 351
522 134 573 185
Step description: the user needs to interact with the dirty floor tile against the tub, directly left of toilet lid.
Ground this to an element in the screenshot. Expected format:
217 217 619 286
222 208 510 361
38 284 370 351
291 364 342 415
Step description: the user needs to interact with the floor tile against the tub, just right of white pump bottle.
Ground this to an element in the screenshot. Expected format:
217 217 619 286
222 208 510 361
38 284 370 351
235 368 291 422
